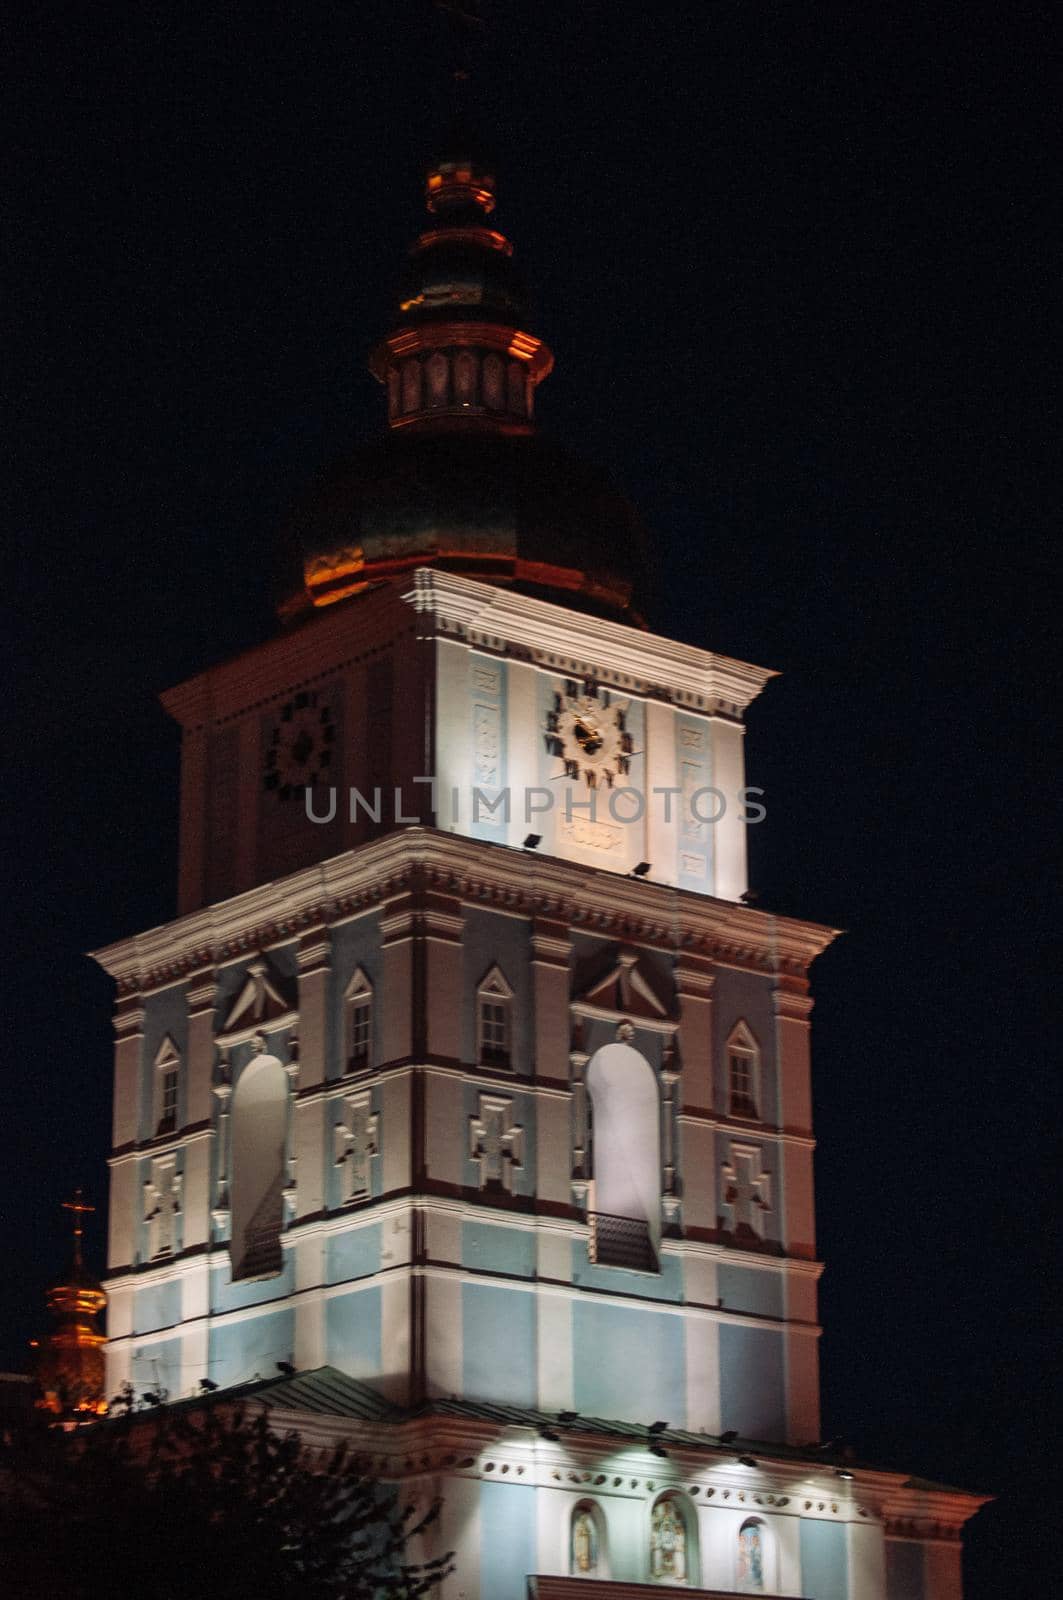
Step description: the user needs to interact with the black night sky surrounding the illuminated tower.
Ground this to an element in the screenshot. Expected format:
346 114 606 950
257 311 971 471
0 0 1058 1600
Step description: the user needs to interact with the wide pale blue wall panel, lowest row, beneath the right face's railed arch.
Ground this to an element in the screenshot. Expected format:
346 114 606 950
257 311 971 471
572 1299 687 1427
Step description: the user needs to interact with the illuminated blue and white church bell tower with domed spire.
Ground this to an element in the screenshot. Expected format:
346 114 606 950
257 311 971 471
98 118 977 1600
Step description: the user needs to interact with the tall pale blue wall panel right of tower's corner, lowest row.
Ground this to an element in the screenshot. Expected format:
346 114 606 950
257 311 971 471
461 1283 536 1408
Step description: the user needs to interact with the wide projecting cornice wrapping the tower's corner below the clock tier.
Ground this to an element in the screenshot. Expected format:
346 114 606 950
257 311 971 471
91 826 837 997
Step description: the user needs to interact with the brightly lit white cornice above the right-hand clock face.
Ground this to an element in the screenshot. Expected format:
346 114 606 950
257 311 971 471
402 566 778 717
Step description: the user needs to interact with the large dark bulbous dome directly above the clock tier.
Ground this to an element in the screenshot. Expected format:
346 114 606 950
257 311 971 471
279 429 645 616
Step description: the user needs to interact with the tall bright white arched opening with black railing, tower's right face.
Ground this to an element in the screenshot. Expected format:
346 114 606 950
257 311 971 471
586 1042 661 1272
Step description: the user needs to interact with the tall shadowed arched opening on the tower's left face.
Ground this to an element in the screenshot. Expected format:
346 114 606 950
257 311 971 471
229 1056 288 1278
